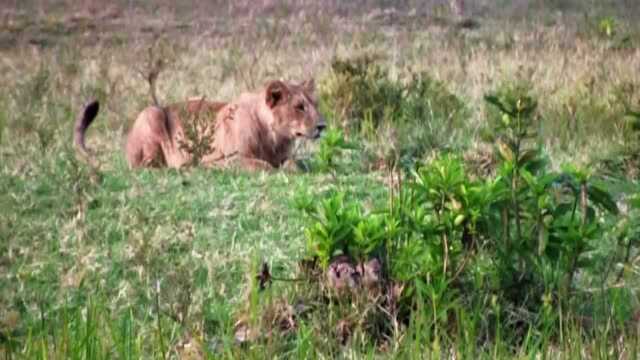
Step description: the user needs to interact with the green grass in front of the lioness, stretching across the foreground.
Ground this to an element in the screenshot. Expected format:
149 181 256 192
0 128 638 359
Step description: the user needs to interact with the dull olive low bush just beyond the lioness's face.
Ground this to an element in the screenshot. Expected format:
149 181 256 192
319 55 469 166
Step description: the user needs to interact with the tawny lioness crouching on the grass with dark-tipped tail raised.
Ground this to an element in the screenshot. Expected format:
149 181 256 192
74 80 326 170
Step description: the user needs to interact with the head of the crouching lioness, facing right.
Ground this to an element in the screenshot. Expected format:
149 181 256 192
264 80 326 139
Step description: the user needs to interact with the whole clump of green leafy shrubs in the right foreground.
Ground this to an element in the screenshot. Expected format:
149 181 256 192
299 78 632 341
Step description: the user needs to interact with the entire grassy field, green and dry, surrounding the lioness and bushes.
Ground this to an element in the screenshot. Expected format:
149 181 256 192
0 0 640 359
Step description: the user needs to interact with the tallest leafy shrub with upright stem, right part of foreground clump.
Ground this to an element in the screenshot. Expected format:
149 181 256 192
485 81 617 310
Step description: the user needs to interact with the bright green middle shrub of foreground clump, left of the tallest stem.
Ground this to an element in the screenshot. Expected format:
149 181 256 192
389 156 497 310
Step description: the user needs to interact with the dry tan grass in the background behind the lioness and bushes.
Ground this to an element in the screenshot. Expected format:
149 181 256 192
0 1 640 163
